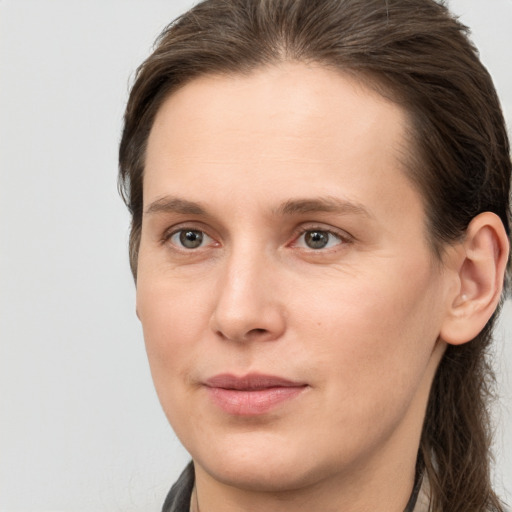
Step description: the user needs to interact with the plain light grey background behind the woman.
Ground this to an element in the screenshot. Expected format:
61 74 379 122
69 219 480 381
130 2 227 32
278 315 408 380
0 0 512 512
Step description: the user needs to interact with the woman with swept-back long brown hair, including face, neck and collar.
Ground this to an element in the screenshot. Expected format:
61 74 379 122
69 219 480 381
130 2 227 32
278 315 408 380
120 0 511 512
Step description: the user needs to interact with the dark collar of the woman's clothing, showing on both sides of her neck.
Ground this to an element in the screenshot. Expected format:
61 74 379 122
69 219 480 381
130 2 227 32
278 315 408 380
162 462 428 512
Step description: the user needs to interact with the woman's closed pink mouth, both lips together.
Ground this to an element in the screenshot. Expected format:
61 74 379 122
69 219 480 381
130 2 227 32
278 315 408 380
205 373 309 416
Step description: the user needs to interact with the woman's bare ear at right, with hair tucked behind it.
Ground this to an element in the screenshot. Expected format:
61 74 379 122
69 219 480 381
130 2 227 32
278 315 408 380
440 212 509 345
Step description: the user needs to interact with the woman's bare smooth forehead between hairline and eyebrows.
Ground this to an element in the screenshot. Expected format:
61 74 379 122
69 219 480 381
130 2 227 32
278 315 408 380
144 63 416 220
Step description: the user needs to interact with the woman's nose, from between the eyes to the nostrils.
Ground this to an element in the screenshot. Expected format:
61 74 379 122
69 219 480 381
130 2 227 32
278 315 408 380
211 249 286 342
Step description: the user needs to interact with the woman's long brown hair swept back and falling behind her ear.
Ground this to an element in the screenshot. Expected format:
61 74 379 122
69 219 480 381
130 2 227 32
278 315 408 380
119 0 511 512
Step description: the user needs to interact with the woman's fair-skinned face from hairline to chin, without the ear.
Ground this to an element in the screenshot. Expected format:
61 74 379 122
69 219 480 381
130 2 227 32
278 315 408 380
137 64 447 490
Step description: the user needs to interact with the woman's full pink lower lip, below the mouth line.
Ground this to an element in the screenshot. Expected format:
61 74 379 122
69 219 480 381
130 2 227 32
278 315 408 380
206 386 306 416
